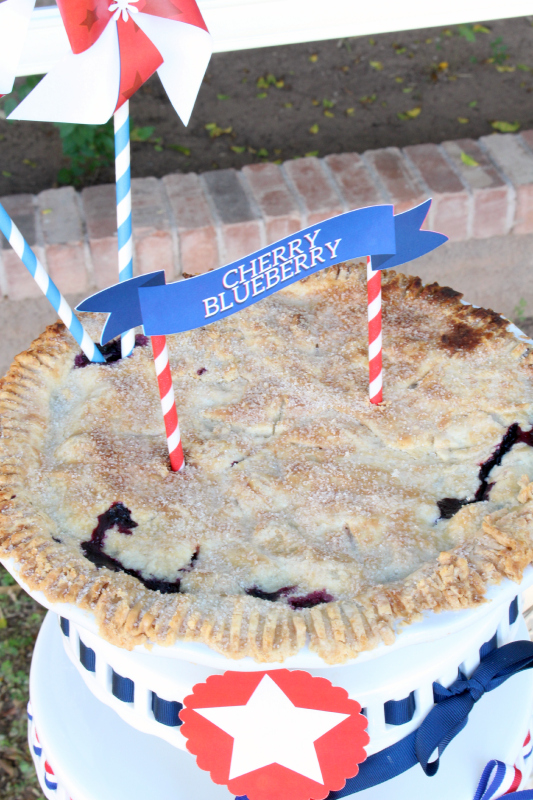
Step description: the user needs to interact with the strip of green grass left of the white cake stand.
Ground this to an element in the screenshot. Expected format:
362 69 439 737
0 566 46 800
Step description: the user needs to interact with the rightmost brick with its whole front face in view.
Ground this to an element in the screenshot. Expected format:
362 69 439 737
442 139 514 239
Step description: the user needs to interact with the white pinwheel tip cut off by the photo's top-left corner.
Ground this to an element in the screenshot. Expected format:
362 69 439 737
0 0 35 97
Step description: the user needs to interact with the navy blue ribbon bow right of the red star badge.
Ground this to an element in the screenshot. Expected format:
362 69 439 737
236 641 533 800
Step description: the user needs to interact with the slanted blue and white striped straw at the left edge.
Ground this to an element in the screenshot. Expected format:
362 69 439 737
0 203 105 364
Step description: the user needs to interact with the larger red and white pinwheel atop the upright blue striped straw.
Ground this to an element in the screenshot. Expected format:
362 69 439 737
8 0 212 125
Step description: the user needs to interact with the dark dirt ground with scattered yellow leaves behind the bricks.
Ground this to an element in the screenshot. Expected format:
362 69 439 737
0 18 533 196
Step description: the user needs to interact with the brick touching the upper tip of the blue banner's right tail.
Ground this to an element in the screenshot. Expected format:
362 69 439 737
403 144 470 242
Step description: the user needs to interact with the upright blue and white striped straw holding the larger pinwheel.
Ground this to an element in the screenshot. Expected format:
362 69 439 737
114 100 135 358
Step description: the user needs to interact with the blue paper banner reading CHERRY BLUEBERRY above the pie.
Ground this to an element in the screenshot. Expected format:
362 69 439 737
77 200 448 344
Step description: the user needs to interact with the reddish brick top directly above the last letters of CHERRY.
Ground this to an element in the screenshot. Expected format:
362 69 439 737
283 156 345 227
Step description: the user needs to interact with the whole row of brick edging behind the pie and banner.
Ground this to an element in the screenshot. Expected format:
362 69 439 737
0 131 533 300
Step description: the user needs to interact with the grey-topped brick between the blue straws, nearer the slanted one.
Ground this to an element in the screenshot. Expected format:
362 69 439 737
37 186 88 294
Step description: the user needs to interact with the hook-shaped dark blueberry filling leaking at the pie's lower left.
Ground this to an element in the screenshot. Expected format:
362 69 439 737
81 503 200 594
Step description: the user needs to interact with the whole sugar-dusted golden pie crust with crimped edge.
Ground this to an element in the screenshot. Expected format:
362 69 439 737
0 264 533 664
